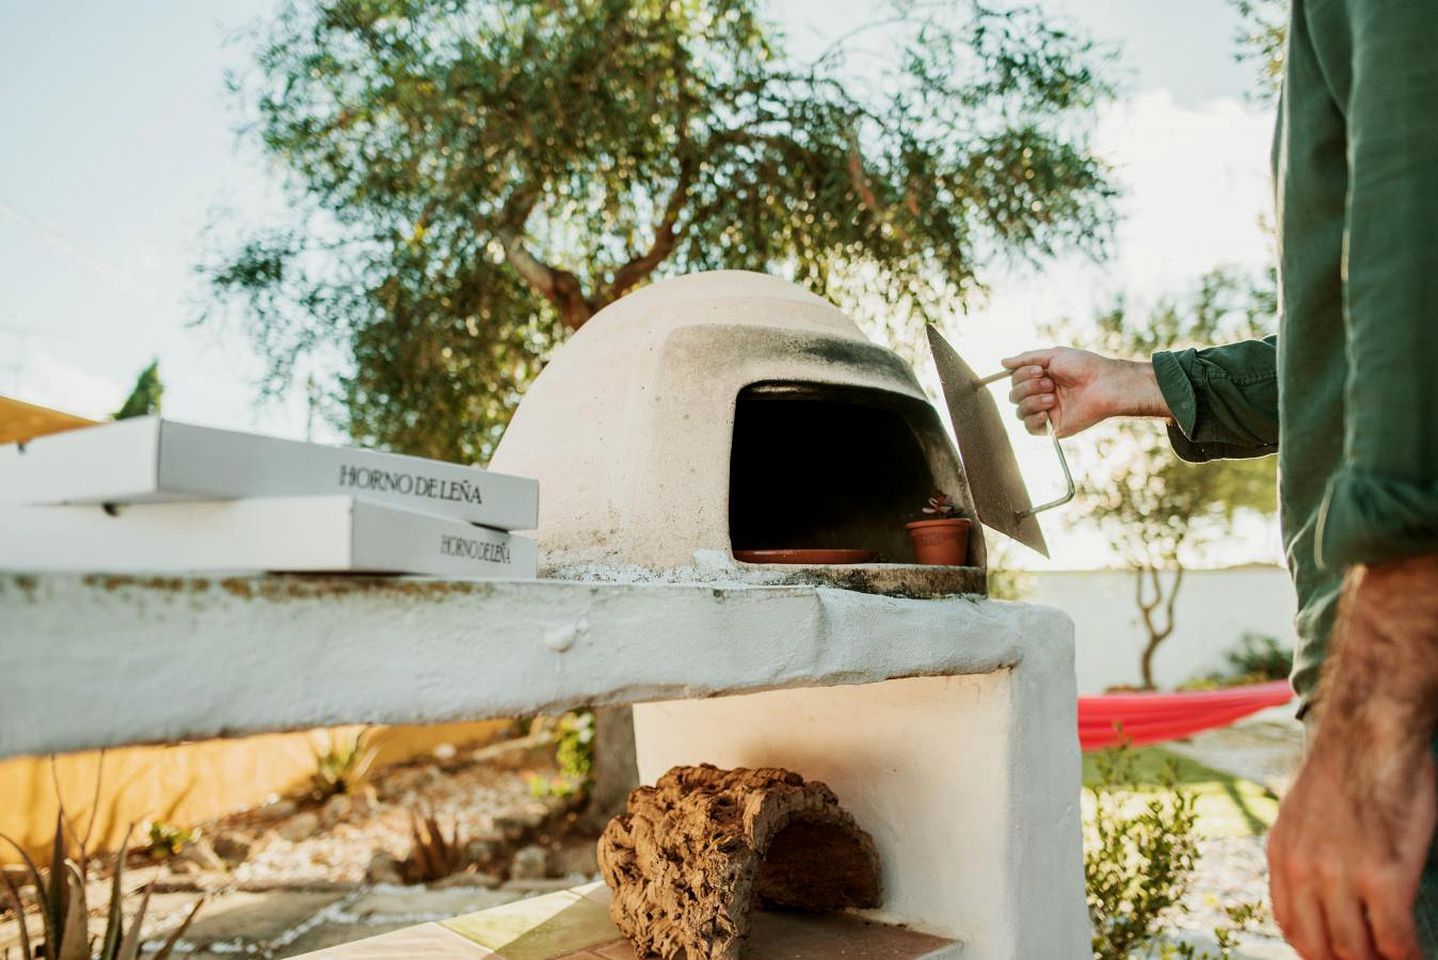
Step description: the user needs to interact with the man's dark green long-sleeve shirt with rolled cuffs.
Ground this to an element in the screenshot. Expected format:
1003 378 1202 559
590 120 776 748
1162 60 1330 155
1153 0 1438 701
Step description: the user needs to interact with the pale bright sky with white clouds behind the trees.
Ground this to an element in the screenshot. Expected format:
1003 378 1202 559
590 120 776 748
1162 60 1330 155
0 0 1277 566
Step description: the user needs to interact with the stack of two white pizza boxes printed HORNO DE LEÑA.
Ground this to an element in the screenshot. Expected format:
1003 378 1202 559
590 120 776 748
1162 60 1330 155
0 417 539 578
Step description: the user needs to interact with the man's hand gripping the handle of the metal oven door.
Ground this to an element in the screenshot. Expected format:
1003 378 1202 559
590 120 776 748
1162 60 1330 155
1004 346 1171 437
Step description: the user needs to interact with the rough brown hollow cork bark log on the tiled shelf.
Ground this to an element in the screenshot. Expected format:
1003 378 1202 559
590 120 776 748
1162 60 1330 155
598 765 880 960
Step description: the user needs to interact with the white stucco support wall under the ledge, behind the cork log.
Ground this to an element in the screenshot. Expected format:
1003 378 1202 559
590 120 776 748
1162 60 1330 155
634 643 1091 960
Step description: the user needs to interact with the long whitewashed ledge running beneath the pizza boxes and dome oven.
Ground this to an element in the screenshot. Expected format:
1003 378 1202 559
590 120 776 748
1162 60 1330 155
0 572 1073 757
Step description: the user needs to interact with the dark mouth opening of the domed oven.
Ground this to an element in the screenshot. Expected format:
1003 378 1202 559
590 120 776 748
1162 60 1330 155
729 382 972 569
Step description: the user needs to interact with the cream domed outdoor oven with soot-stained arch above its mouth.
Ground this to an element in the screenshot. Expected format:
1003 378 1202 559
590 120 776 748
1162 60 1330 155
490 270 982 573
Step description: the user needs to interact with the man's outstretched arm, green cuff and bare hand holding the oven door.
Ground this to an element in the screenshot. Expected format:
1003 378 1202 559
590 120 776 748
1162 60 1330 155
1004 336 1278 461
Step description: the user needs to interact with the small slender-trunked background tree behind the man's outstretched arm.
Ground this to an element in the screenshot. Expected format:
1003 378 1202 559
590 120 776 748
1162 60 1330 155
1058 270 1277 688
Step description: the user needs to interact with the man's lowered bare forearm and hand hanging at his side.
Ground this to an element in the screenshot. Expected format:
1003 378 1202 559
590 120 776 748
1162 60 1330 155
1268 555 1438 960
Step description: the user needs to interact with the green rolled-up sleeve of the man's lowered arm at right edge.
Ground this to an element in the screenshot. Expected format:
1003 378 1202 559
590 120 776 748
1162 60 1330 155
1316 0 1438 568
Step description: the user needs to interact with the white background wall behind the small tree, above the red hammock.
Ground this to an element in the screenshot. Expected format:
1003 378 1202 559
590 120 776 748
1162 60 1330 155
1024 566 1296 693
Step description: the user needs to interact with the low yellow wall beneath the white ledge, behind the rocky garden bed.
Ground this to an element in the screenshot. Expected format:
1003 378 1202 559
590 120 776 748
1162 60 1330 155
0 720 509 864
